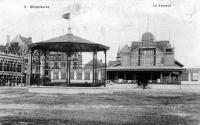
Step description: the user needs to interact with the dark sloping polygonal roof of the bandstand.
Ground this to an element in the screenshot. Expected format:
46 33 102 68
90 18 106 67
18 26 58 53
28 30 109 52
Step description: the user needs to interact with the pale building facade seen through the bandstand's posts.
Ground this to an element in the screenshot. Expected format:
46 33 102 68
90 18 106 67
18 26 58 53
29 52 105 85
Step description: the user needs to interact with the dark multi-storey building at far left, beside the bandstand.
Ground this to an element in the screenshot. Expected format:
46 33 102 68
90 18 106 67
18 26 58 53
0 35 32 85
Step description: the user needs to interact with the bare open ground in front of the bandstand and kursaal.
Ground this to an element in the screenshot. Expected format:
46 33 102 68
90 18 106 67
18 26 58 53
0 87 200 125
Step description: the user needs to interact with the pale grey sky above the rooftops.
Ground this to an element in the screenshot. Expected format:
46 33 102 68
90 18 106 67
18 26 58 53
0 0 200 68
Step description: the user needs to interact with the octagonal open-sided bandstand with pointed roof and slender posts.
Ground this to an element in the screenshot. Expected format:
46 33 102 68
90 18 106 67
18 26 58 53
27 27 109 86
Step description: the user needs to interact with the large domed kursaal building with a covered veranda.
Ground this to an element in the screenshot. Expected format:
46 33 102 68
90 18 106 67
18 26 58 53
107 32 185 84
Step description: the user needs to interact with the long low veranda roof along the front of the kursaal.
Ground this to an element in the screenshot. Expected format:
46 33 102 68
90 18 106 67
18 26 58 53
107 66 185 71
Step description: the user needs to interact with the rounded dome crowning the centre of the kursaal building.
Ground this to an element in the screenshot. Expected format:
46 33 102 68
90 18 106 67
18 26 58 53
142 32 155 45
